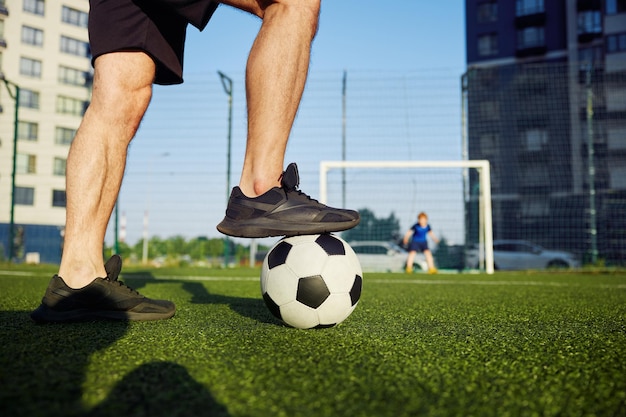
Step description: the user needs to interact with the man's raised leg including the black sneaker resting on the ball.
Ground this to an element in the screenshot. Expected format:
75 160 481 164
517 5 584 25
217 0 359 237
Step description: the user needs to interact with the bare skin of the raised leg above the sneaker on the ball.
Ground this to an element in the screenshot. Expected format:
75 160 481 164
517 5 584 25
222 0 320 197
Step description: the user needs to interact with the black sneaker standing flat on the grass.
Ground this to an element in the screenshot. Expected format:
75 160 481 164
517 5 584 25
30 255 176 323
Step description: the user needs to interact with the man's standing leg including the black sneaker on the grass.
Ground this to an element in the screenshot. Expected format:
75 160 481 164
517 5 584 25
30 52 176 323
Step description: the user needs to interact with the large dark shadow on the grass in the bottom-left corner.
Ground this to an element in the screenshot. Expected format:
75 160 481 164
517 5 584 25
0 311 228 417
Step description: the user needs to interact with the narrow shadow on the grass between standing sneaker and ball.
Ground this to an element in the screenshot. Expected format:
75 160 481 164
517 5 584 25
122 271 282 326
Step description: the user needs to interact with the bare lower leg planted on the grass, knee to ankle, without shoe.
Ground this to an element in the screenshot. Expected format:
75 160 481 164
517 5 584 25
59 52 155 288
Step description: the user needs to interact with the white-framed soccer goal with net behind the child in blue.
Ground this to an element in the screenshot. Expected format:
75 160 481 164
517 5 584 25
320 160 494 273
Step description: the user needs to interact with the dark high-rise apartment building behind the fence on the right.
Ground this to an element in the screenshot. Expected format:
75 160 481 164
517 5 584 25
463 0 626 263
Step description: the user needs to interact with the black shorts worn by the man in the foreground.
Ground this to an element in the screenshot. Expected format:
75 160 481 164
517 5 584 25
89 0 218 84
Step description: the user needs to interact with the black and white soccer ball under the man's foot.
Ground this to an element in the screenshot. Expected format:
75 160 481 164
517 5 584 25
261 234 363 329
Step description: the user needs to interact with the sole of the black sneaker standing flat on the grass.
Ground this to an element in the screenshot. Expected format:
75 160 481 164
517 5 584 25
30 304 176 323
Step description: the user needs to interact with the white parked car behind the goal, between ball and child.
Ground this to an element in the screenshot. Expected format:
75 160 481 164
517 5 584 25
350 241 428 272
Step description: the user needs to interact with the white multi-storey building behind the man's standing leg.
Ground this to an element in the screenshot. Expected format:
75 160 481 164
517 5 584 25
0 0 92 262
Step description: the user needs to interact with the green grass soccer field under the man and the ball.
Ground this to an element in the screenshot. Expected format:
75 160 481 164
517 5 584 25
0 265 626 417
